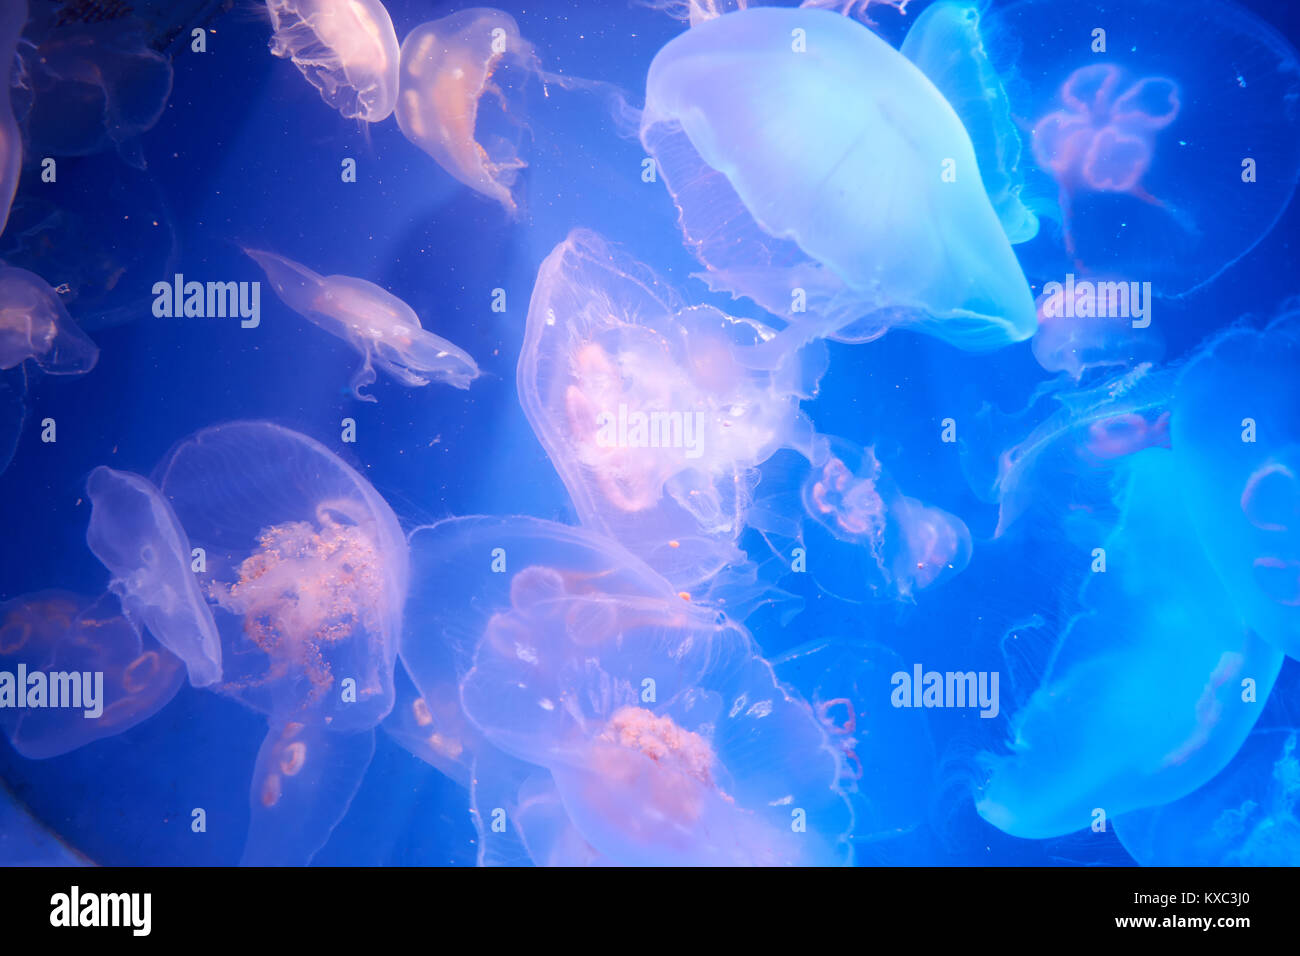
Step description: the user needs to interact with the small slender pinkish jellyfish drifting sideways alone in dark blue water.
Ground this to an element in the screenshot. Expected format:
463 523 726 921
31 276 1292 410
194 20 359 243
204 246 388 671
244 248 478 402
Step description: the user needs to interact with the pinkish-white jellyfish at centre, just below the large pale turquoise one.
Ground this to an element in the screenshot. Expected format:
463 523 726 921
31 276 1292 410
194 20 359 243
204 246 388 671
517 230 826 591
